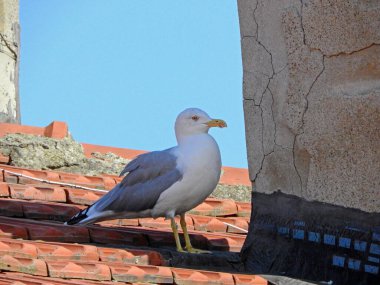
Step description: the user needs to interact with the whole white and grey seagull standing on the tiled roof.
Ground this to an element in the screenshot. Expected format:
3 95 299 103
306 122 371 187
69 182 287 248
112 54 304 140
65 108 227 253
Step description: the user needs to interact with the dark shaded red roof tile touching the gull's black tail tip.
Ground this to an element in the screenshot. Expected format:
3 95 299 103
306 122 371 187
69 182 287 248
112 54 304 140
22 201 80 222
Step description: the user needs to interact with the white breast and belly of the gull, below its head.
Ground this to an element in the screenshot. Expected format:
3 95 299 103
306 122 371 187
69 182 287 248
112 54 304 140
152 134 221 217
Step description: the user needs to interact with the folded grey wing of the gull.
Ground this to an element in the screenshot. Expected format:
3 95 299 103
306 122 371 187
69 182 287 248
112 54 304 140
93 149 182 213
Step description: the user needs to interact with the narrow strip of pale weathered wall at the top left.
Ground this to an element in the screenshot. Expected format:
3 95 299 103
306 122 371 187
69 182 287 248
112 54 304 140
0 0 20 123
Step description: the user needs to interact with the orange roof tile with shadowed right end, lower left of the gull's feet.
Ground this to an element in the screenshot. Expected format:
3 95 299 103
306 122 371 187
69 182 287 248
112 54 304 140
98 247 165 266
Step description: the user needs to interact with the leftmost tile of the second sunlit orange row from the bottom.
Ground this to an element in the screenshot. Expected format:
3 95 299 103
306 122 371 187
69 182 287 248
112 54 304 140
0 238 37 259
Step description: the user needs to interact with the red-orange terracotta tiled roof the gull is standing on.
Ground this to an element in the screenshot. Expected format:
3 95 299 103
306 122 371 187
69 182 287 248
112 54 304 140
0 122 268 285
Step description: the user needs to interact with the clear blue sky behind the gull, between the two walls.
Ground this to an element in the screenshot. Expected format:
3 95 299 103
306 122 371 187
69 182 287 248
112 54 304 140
20 0 247 167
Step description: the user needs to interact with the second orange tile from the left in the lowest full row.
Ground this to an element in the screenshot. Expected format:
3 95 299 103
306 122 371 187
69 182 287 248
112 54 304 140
47 261 111 281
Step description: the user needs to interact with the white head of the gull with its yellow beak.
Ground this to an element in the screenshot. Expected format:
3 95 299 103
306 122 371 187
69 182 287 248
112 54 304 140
175 108 227 140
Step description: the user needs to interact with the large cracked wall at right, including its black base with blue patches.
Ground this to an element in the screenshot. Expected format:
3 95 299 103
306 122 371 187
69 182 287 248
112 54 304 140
238 0 380 285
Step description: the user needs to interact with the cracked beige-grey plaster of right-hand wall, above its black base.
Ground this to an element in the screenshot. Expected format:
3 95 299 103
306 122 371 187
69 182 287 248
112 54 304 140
238 0 380 212
